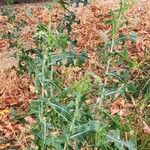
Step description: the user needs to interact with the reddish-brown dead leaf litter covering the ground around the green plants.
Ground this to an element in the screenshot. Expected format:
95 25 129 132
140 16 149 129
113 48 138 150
0 0 150 149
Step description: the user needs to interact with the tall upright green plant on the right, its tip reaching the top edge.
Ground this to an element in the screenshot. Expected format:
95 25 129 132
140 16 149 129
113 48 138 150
95 0 134 104
